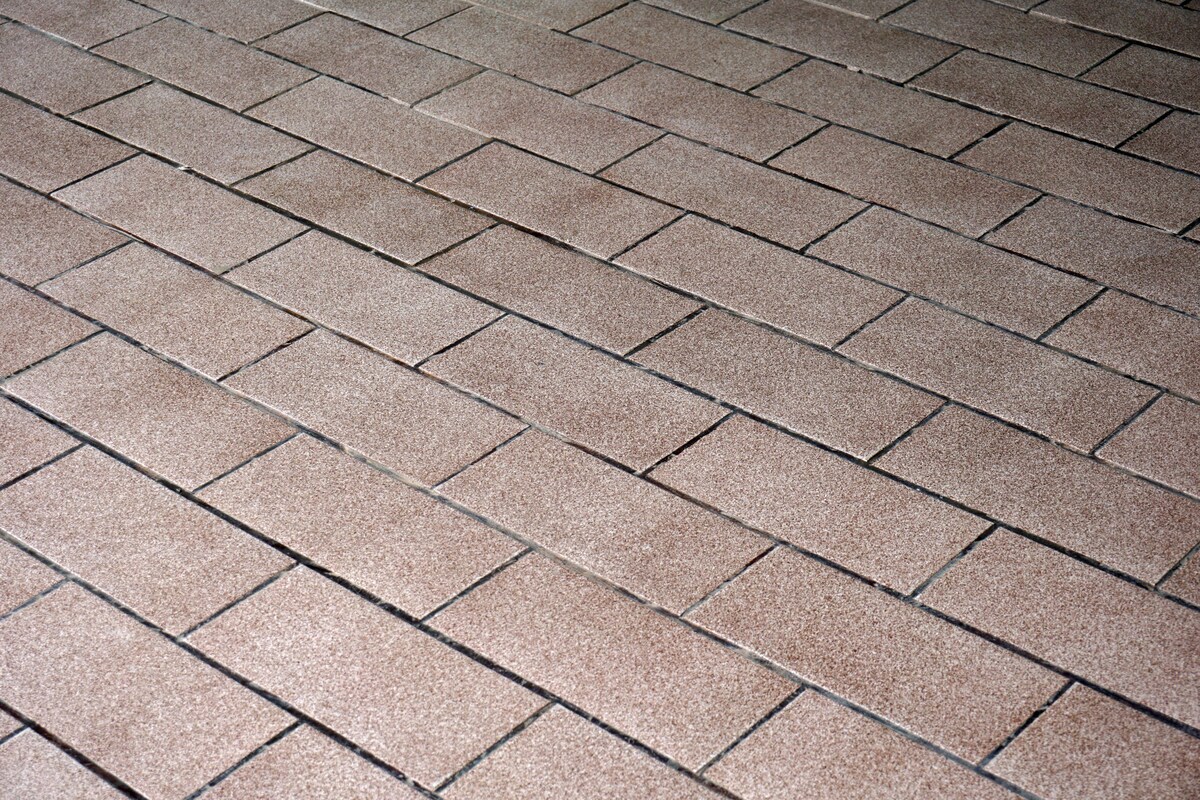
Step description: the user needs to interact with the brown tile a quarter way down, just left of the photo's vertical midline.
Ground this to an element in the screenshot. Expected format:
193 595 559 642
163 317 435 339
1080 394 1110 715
421 143 679 258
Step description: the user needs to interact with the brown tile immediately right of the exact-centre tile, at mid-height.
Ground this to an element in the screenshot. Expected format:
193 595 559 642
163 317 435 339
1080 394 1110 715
636 311 941 458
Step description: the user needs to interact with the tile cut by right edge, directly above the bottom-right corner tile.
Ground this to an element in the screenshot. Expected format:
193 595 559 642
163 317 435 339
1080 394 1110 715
922 530 1200 726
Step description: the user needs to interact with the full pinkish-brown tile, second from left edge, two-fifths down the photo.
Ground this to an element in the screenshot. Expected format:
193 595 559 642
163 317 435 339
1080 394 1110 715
42 243 311 378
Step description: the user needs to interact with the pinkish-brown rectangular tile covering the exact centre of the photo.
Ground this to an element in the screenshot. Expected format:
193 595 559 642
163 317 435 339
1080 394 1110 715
426 317 724 469
